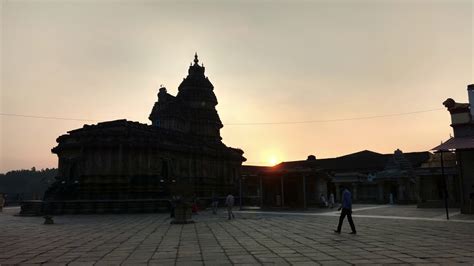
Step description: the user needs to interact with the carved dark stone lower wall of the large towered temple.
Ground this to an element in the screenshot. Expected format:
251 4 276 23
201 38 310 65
54 145 240 199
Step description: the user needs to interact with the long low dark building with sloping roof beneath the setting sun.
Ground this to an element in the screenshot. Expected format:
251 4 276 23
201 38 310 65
242 150 431 207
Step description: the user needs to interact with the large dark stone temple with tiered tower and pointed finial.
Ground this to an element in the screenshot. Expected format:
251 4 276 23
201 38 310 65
24 54 245 212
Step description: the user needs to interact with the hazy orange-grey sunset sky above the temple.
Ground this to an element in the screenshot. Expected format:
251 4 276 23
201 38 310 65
0 0 474 173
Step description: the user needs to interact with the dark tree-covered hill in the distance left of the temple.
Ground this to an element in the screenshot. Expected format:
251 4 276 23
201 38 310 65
0 167 58 203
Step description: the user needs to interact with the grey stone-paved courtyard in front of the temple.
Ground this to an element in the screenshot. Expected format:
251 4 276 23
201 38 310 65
0 205 474 265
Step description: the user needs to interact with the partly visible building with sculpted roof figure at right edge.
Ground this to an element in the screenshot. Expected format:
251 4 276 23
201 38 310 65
433 84 474 213
